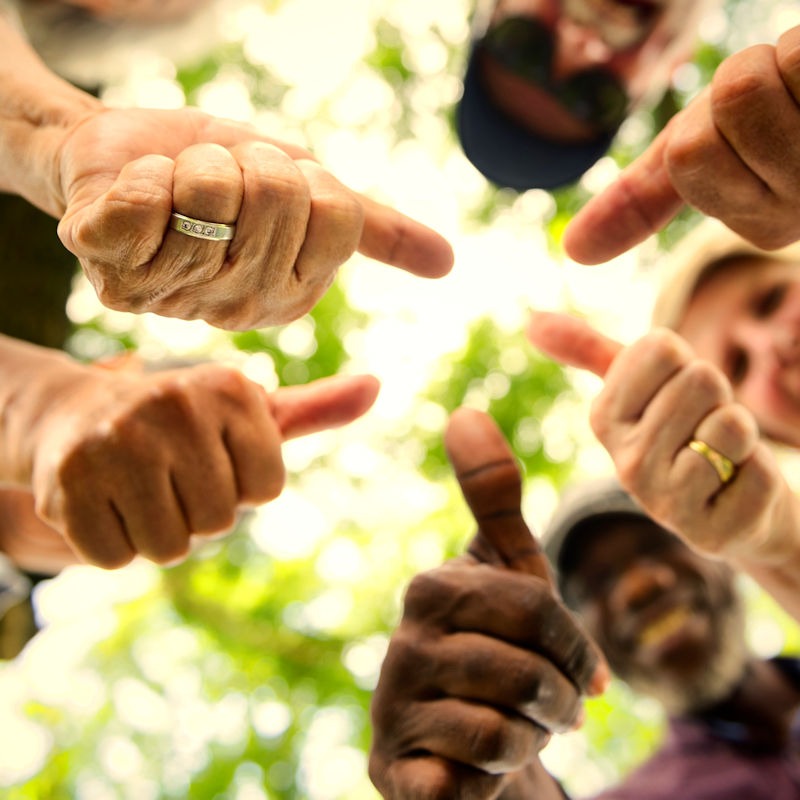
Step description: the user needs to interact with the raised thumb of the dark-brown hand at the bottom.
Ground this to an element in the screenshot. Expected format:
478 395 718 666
444 408 555 591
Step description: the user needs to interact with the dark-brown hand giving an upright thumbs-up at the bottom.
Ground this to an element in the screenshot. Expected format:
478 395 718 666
370 409 608 800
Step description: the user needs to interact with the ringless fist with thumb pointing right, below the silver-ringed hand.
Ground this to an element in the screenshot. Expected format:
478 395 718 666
32 364 378 568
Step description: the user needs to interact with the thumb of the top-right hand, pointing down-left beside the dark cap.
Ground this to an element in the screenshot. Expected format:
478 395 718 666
564 123 683 264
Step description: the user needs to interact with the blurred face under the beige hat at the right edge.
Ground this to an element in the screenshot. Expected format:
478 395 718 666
676 256 800 447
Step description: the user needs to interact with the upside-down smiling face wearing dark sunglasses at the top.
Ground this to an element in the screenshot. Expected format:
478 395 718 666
481 0 718 143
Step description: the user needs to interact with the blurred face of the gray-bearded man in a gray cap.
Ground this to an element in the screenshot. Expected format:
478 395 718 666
565 515 747 713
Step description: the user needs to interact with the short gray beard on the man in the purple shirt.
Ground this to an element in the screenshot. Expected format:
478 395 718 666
615 595 750 716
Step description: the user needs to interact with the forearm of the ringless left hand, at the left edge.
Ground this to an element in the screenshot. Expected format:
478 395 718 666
0 336 90 487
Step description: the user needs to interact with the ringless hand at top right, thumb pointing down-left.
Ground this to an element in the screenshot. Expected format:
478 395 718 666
564 26 800 264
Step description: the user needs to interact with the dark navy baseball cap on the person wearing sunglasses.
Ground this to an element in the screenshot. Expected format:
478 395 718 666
456 43 616 191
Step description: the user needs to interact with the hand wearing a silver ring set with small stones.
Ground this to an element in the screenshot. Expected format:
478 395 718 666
52 109 453 330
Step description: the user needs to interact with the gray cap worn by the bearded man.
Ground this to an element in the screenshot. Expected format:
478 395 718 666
542 476 650 591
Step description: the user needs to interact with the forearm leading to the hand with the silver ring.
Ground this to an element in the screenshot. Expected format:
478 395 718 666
0 8 103 217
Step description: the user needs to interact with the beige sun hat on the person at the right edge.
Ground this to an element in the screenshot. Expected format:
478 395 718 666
652 219 800 330
